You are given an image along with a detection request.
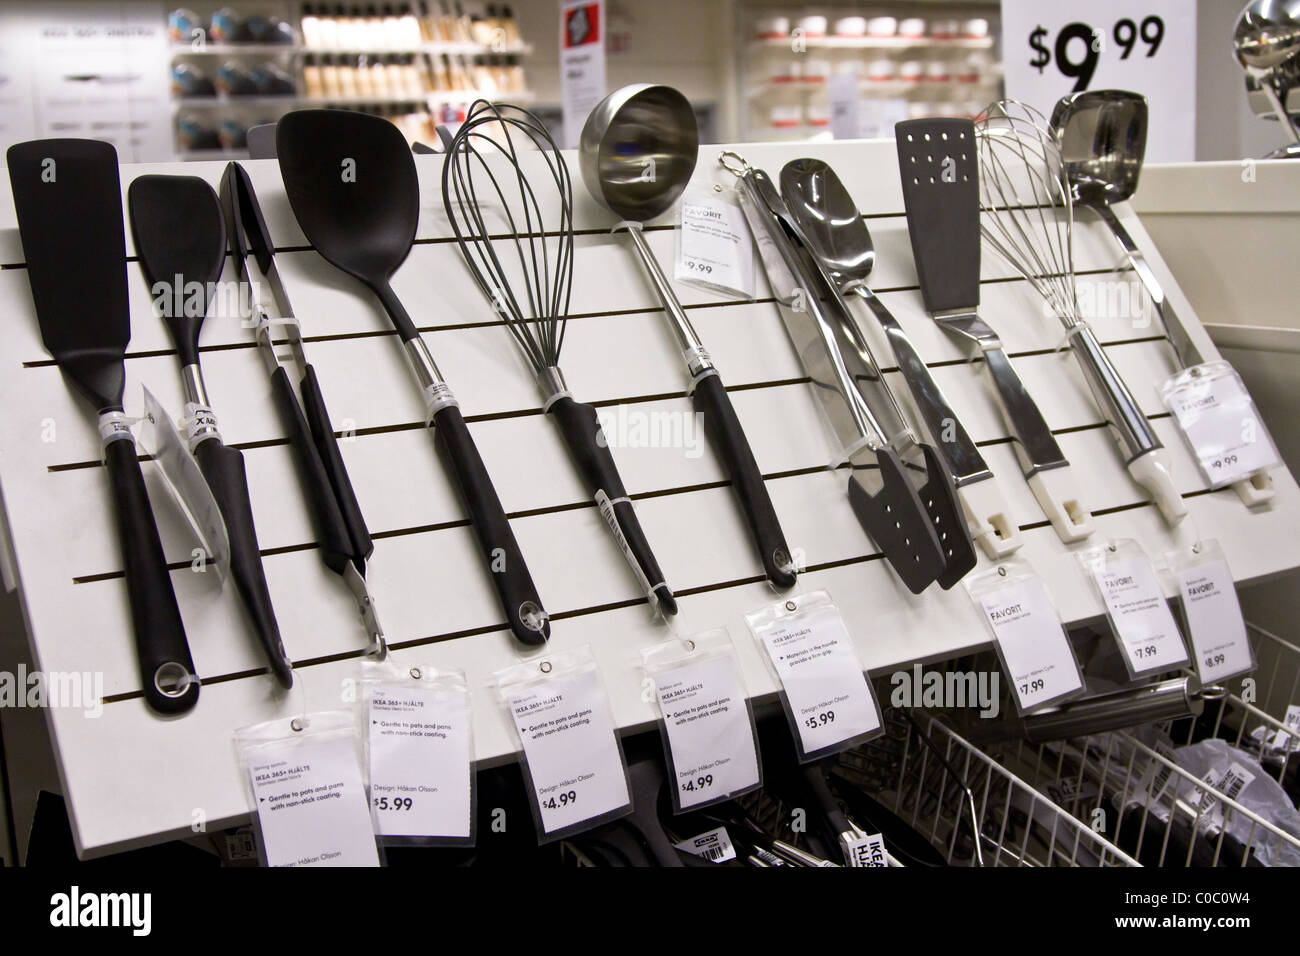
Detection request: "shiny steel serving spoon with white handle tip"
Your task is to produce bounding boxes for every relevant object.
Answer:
[781,159,1023,561]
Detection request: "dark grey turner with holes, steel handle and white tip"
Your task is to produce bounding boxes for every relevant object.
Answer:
[894,118,1093,542]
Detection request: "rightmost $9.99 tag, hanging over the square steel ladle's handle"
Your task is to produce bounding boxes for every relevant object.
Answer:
[1164,362,1278,488]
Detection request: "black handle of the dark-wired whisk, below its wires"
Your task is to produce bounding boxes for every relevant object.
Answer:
[549,398,677,614]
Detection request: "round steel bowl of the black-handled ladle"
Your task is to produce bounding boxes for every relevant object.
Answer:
[579,83,699,222]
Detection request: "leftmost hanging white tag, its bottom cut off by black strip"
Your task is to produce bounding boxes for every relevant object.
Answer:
[248,736,380,866]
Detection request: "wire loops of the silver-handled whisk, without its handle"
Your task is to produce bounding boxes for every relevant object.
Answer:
[975,100,1083,329]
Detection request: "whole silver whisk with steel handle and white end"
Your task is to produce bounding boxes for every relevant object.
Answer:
[975,100,1187,523]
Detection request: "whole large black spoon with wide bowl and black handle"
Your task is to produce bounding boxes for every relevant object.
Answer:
[276,109,550,645]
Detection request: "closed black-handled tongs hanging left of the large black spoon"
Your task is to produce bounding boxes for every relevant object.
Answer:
[221,163,387,658]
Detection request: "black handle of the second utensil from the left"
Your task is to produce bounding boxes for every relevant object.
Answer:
[194,438,294,687]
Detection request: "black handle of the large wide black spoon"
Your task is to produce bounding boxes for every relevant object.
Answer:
[433,405,551,645]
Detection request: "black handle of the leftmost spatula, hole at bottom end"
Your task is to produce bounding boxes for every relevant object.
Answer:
[104,438,199,714]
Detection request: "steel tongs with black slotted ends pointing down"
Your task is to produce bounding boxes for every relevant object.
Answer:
[719,152,975,594]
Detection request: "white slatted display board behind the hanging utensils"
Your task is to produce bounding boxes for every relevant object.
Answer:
[0,142,1300,855]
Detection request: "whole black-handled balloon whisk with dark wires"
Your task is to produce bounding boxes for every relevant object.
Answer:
[442,100,677,614]
